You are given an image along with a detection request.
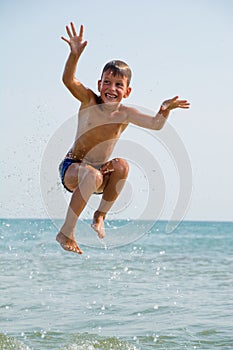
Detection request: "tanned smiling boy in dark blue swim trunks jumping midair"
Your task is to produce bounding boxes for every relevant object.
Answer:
[56,23,189,254]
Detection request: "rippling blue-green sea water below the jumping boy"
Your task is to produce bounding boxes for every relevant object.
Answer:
[0,219,233,350]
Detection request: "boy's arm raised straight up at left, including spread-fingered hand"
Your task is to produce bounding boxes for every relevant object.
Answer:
[62,23,93,104]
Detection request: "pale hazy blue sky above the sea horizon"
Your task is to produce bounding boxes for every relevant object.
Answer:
[0,0,233,221]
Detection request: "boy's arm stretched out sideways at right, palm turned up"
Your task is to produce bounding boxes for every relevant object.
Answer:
[126,96,190,130]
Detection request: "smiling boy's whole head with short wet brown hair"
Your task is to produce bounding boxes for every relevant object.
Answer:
[98,60,132,103]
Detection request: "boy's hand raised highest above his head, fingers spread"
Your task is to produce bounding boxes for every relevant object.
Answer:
[61,22,87,55]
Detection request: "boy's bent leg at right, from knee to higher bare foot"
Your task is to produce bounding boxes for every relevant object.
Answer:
[92,158,129,238]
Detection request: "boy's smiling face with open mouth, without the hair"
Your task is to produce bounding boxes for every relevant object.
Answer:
[98,71,131,103]
